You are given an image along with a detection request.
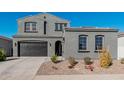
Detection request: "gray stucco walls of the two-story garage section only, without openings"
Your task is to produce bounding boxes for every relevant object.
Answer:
[13,13,70,56]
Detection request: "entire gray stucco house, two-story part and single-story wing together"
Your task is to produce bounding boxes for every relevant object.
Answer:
[13,13,118,59]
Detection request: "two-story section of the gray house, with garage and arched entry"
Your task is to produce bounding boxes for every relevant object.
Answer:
[13,13,69,56]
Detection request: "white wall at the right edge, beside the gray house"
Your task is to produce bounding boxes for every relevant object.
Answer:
[118,37,124,59]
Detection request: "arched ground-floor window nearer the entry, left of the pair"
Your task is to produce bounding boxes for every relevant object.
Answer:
[79,35,87,50]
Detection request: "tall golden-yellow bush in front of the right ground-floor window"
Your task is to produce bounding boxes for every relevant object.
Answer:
[100,48,112,68]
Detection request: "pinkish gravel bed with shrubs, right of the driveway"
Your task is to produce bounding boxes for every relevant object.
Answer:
[37,49,124,75]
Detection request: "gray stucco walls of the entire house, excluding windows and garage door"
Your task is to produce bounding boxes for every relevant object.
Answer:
[13,13,118,59]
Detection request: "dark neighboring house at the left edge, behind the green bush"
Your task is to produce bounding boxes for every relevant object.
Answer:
[0,36,12,56]
